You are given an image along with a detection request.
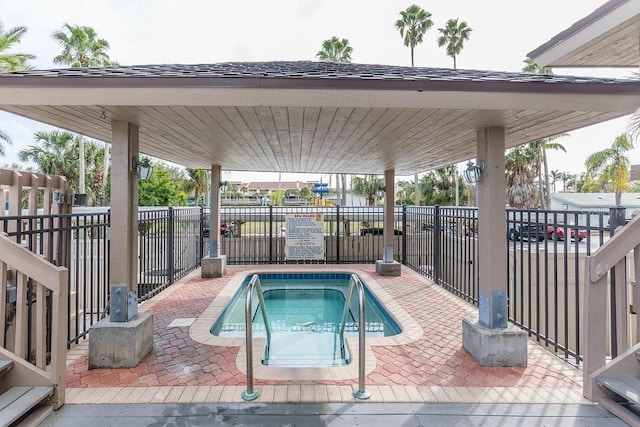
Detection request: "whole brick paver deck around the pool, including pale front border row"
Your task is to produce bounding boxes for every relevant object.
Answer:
[67,265,588,403]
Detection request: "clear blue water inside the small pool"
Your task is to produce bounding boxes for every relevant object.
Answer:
[211,273,400,366]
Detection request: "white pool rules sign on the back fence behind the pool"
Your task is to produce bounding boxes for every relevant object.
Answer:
[284,213,324,260]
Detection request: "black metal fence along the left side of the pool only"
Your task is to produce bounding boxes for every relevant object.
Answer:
[0,208,202,354]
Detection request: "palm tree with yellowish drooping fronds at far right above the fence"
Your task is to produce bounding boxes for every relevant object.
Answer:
[584,133,633,206]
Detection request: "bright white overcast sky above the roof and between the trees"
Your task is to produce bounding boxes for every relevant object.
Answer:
[0,0,640,182]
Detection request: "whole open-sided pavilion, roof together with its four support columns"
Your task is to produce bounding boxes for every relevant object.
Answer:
[0,62,640,367]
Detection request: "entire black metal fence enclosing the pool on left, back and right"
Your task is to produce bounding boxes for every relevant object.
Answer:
[0,202,616,363]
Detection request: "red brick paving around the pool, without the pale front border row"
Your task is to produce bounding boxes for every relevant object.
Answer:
[67,265,578,388]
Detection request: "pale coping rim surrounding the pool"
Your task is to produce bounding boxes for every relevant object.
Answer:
[189,265,424,381]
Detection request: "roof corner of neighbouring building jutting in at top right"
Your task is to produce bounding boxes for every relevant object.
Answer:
[527,0,640,68]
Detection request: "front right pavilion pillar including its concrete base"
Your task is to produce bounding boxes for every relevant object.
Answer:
[462,127,527,366]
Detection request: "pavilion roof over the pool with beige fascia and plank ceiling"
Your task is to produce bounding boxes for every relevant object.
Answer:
[0,62,640,175]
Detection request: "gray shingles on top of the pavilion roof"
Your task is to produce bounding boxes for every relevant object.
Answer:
[0,61,637,86]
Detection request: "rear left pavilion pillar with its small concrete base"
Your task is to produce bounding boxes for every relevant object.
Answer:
[200,165,227,278]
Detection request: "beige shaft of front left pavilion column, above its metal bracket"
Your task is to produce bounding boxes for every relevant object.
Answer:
[109,121,138,290]
